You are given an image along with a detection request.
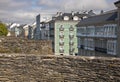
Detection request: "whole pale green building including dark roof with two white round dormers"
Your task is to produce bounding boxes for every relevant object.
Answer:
[49,12,86,55]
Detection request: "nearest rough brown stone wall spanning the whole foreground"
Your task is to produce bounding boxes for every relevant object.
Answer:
[0,54,120,82]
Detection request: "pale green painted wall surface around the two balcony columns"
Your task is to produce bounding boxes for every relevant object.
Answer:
[54,21,78,55]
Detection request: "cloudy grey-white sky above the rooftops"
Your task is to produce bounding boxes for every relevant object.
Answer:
[0,0,117,24]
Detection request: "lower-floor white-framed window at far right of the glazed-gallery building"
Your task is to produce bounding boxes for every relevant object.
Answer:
[107,40,117,55]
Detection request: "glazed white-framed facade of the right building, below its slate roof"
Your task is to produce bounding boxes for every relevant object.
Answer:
[77,23,117,56]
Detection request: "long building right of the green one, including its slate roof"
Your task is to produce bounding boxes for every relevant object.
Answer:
[77,10,119,56]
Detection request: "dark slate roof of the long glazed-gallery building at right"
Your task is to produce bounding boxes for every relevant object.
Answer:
[76,11,117,26]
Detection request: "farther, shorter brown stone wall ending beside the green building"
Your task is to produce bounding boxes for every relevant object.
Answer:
[0,37,53,55]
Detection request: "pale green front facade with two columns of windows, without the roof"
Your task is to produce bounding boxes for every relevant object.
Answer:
[54,21,78,55]
